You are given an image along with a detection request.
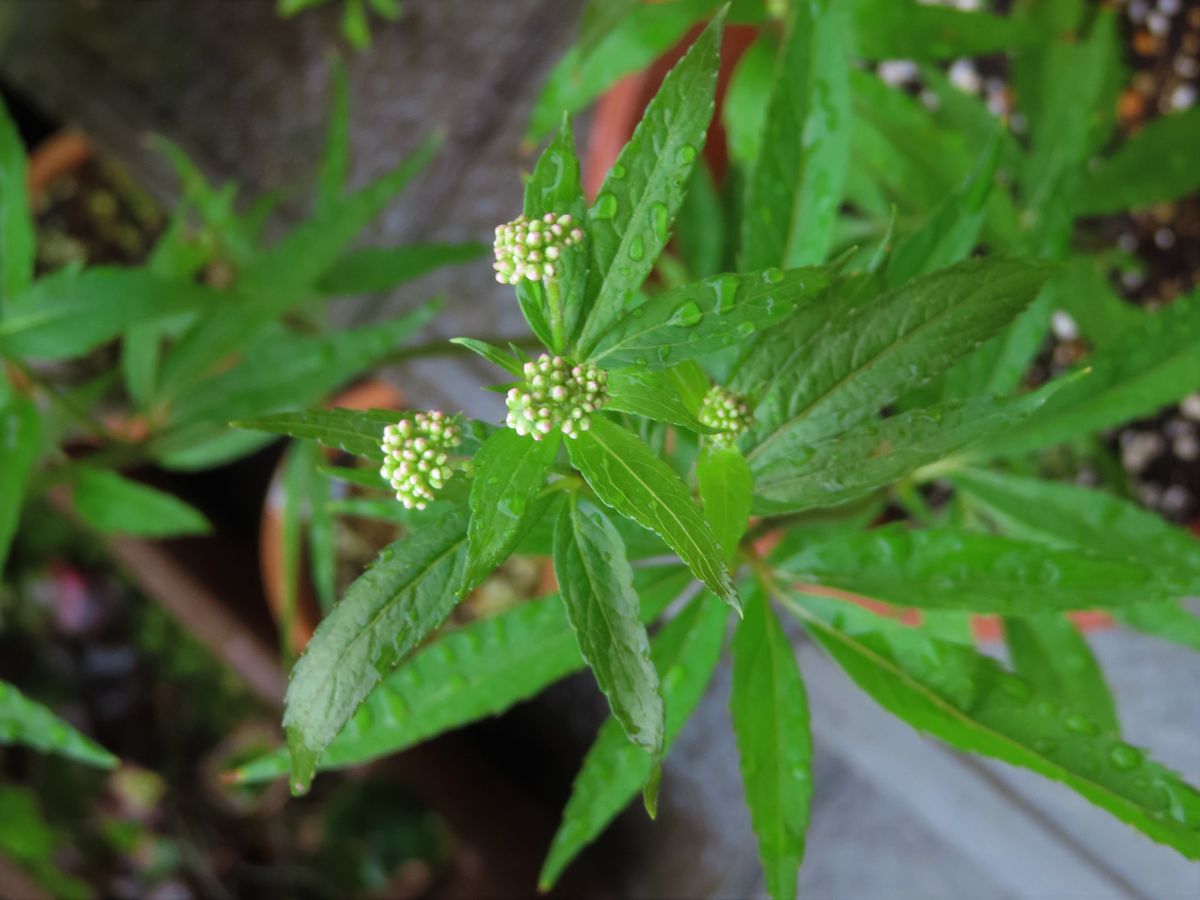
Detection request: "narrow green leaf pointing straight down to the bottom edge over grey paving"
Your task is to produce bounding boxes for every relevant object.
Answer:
[730,592,812,900]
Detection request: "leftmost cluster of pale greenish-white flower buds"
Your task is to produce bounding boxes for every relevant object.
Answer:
[379,412,462,509]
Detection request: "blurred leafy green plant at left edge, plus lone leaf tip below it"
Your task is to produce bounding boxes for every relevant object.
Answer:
[0,67,485,766]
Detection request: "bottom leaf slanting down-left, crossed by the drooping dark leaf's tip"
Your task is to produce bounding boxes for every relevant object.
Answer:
[538,594,727,890]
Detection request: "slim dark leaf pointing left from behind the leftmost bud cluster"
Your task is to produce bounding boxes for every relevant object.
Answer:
[232,408,487,464]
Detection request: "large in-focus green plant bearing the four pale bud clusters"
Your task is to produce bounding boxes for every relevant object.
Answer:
[231,1,1200,896]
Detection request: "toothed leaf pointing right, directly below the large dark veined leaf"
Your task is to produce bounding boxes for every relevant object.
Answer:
[751,376,1065,514]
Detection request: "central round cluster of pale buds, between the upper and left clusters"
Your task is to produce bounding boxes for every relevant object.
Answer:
[505,354,608,440]
